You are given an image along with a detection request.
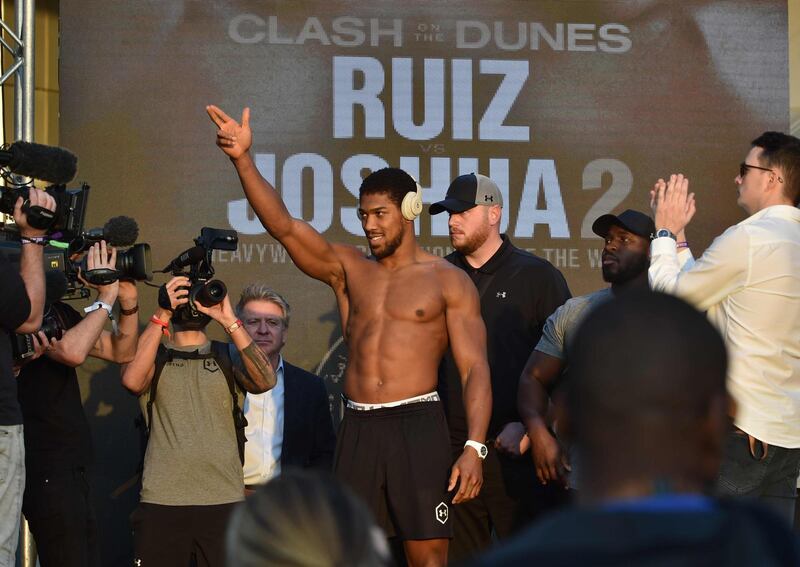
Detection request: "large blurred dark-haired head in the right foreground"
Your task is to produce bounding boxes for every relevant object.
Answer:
[567,293,729,503]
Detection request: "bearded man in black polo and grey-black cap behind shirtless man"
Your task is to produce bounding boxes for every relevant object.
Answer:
[430,173,570,562]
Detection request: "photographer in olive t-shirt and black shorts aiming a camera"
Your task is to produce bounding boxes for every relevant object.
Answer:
[122,229,276,567]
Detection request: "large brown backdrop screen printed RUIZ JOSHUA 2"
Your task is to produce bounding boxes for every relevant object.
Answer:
[60,0,789,560]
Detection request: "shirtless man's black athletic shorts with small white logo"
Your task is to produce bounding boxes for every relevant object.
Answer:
[334,401,453,540]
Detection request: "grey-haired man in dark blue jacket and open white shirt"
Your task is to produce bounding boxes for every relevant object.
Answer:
[236,284,336,490]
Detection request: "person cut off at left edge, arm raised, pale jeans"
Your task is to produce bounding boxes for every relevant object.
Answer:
[0,188,55,565]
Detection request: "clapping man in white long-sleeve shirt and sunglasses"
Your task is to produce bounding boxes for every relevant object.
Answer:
[649,132,800,521]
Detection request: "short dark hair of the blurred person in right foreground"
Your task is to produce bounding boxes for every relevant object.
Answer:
[565,291,727,475]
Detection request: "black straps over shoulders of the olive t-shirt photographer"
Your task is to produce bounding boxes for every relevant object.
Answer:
[144,341,247,465]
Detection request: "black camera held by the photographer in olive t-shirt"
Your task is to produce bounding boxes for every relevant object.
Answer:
[158,227,239,322]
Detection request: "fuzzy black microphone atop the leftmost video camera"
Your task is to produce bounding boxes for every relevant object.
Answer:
[0,142,78,185]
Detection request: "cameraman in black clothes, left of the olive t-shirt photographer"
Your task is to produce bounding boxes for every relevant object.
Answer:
[18,240,139,567]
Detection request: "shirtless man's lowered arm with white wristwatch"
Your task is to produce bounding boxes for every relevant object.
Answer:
[442,267,492,504]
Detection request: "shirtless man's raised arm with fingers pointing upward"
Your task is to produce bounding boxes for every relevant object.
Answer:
[206,105,344,287]
